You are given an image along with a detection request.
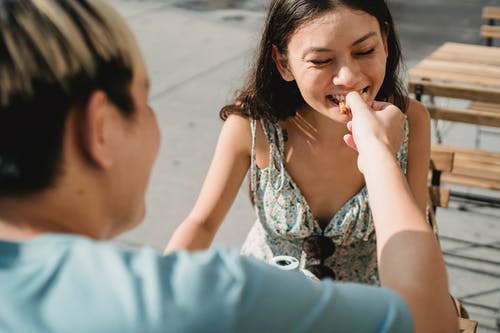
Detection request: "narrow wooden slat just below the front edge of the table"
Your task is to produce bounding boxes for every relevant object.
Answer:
[427,106,500,127]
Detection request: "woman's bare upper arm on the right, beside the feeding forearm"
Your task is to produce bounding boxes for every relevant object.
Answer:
[406,99,430,212]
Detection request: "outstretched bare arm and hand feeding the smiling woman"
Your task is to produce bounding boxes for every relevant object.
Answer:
[344,92,457,332]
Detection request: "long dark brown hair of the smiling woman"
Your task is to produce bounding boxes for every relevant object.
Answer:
[220,0,407,122]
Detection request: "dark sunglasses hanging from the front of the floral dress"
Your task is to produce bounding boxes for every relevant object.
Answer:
[302,235,335,280]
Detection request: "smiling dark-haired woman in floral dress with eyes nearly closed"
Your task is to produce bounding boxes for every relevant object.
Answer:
[167,0,429,284]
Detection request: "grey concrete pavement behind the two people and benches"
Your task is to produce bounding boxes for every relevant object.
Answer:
[110,0,500,332]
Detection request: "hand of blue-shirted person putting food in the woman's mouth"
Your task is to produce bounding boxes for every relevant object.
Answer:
[344,92,406,172]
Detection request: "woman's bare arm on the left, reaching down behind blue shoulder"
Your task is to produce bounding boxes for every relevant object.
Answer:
[165,115,251,252]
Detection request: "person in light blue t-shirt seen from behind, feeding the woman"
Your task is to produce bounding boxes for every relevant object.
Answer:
[0,0,457,333]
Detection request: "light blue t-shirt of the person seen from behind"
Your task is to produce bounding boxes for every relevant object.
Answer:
[0,234,413,333]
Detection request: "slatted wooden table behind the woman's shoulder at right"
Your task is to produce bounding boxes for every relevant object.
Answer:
[408,43,500,127]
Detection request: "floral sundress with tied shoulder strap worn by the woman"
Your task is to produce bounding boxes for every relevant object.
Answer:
[241,119,409,285]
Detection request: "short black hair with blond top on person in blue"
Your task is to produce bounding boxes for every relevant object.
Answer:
[0,0,134,197]
